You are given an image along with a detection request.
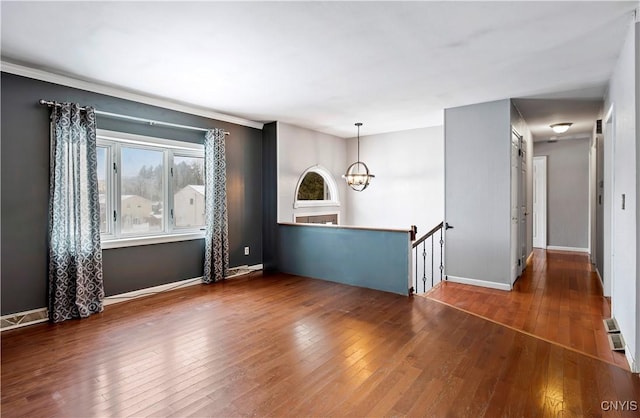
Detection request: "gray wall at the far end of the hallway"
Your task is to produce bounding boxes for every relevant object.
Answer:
[533,139,589,249]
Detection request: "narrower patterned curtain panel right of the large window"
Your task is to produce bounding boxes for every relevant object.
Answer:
[202,129,229,283]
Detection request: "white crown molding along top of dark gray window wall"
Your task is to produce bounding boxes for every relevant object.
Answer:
[0,61,264,129]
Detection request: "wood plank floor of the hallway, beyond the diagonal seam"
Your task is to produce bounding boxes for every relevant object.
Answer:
[426,249,629,370]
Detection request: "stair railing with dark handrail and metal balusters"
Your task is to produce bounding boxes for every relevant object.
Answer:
[409,222,446,294]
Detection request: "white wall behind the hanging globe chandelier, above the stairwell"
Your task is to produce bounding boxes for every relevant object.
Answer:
[343,126,444,236]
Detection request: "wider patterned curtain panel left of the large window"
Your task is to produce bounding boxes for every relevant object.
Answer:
[49,103,104,322]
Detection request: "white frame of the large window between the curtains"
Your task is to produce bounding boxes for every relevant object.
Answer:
[96,129,204,249]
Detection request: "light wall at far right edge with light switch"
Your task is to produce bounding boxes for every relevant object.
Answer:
[604,18,640,372]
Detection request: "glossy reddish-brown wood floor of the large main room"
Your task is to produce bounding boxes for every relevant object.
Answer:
[0,266,640,417]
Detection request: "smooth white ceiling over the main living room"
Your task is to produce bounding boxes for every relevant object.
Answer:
[1,1,639,137]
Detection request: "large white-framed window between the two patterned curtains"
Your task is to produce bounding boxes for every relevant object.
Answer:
[97,130,205,248]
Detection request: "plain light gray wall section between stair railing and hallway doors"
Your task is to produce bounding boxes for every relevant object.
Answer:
[444,99,511,289]
